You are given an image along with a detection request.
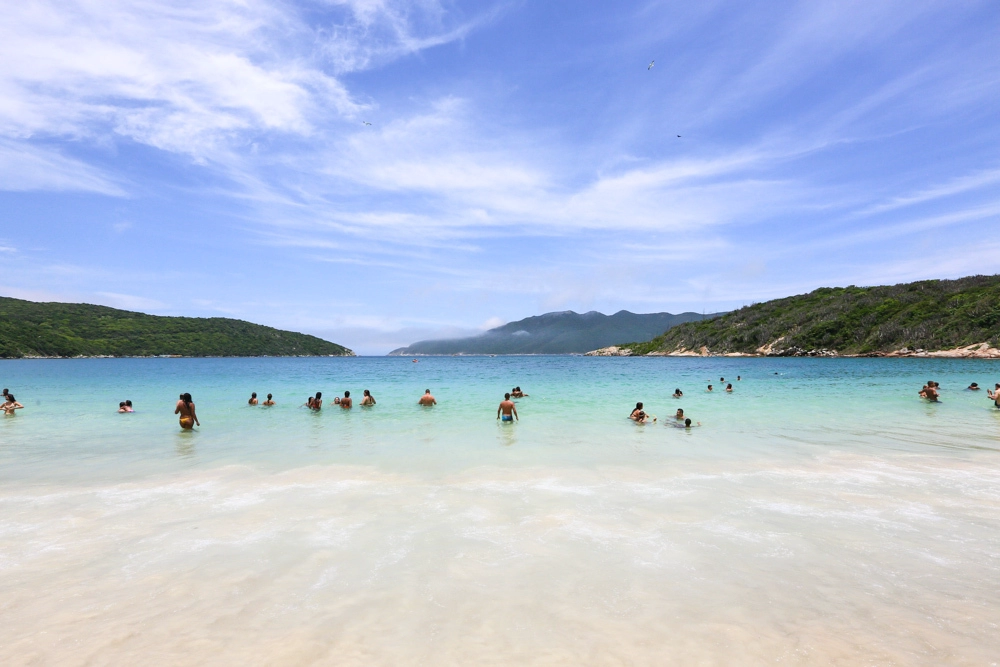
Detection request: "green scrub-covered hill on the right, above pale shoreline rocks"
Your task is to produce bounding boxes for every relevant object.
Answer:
[623,276,1000,356]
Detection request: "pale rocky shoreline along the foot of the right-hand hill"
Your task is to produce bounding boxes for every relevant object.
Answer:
[584,339,1000,359]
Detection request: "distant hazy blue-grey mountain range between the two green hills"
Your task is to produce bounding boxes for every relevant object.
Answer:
[389,310,718,356]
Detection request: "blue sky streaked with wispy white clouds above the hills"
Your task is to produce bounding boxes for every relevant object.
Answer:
[0,0,1000,354]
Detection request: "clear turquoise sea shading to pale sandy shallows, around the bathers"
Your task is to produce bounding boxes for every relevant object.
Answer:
[0,357,1000,665]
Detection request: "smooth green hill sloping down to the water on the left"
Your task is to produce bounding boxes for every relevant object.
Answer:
[0,297,354,358]
